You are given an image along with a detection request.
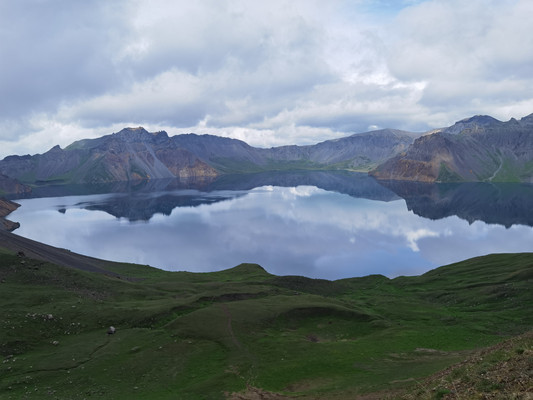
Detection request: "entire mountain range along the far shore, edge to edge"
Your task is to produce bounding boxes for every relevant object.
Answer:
[0,114,533,193]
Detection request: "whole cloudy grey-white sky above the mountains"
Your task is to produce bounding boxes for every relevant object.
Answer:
[0,0,533,157]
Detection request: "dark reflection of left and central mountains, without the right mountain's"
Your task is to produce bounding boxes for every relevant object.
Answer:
[21,171,399,222]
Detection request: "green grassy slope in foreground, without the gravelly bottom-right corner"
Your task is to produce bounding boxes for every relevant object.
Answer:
[0,250,533,399]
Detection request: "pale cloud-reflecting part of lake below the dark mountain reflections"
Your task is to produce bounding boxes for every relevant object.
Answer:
[12,186,533,279]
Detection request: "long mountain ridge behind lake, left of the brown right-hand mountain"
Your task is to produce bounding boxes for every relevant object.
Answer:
[0,128,417,185]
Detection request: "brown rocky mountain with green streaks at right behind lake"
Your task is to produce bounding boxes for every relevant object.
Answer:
[370,114,533,182]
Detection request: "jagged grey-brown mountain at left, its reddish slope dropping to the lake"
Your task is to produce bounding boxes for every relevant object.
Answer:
[0,128,217,184]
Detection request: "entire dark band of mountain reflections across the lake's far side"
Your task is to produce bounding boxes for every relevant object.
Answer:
[35,171,533,228]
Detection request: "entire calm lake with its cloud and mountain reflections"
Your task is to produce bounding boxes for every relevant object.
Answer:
[9,172,533,279]
